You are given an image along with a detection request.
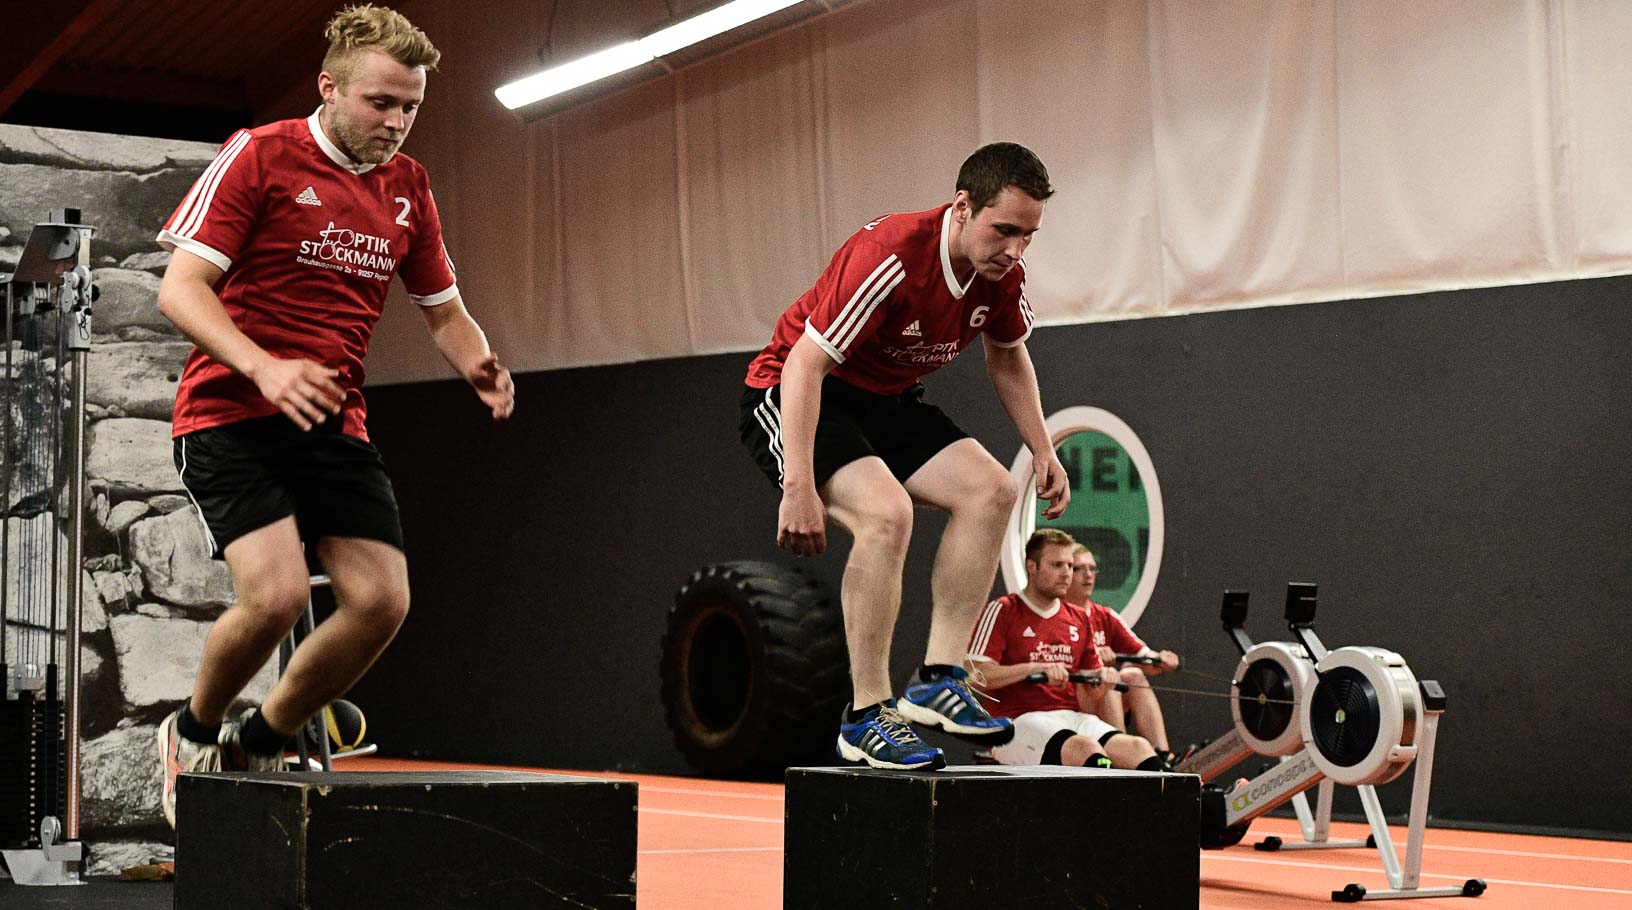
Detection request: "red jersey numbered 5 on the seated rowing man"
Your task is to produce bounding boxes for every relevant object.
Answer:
[969,594,1100,718]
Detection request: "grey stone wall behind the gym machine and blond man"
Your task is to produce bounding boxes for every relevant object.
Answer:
[0,124,273,874]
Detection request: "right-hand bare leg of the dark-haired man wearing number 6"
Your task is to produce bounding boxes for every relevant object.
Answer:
[906,439,1017,667]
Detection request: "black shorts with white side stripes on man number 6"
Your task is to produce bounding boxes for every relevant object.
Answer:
[738,377,969,488]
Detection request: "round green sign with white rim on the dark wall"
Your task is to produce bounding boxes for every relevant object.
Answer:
[1002,408,1162,625]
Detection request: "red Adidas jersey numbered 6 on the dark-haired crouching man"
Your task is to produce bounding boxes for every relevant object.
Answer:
[747,204,1031,395]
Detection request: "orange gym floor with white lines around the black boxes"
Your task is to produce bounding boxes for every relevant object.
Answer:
[347,757,1632,910]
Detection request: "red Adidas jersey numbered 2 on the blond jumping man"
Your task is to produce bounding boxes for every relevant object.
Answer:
[158,114,459,439]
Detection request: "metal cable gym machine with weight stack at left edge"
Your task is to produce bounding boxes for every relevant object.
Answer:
[0,209,96,886]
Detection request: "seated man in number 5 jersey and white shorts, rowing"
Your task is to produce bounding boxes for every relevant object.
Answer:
[968,528,1169,771]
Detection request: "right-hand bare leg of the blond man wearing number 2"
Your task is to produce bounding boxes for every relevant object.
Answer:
[261,537,408,736]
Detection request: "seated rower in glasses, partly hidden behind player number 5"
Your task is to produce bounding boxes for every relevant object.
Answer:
[1066,543,1178,765]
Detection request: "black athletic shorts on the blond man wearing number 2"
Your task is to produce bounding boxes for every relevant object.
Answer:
[173,414,403,559]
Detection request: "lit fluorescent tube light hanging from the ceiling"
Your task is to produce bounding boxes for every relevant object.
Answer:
[493,0,801,111]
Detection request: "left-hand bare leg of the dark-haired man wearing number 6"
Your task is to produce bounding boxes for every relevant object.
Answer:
[821,457,912,708]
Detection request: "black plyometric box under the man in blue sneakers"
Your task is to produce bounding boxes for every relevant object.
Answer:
[782,766,1201,910]
